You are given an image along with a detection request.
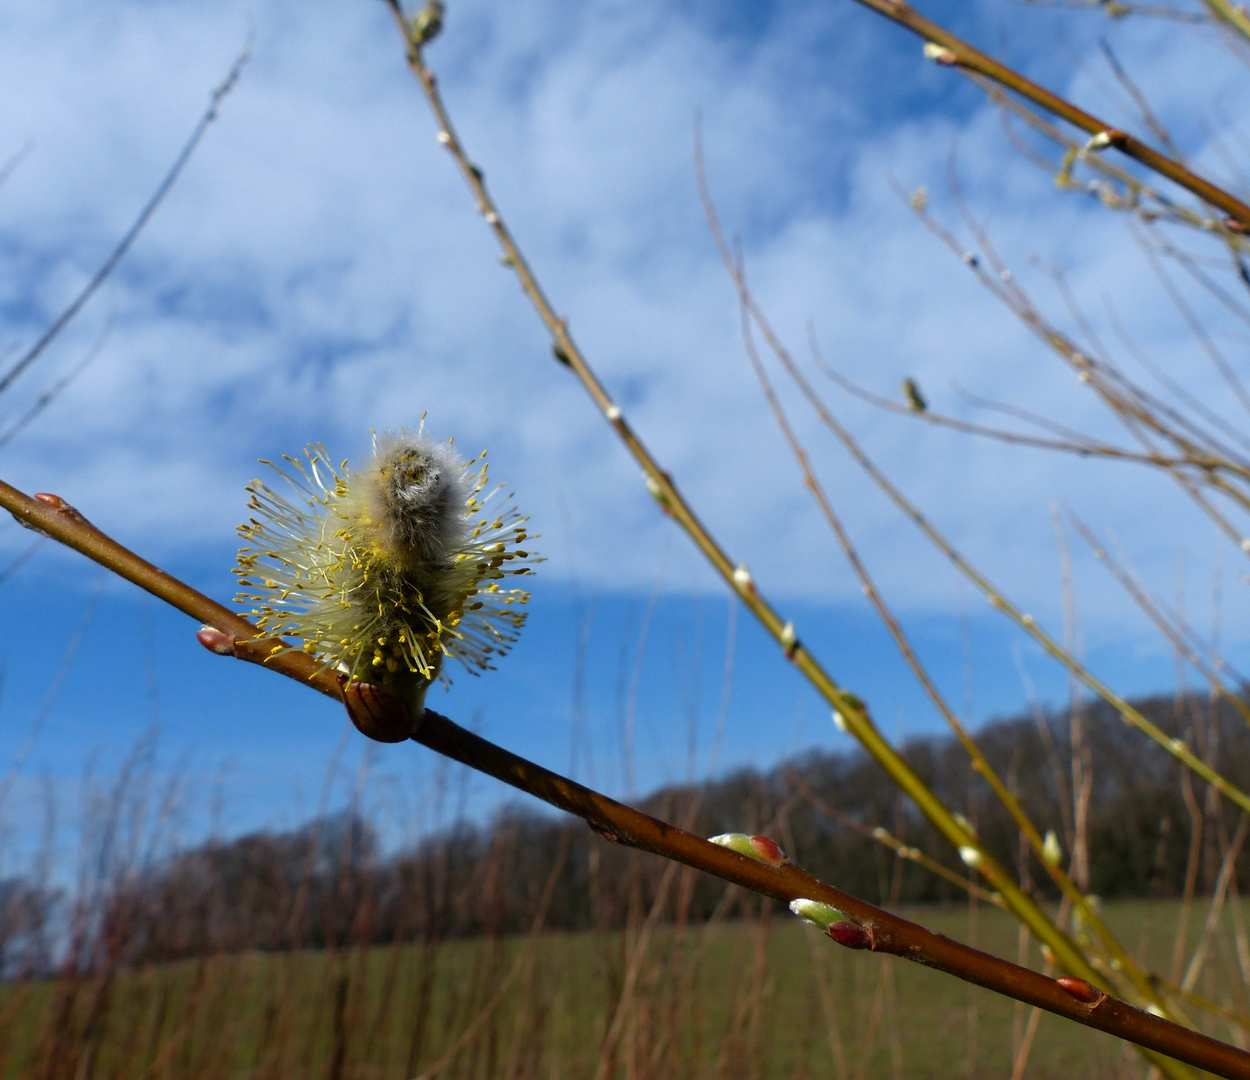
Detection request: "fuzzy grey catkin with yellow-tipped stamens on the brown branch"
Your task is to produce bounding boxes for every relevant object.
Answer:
[235,433,535,711]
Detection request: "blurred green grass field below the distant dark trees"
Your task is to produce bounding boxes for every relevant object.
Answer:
[0,901,1246,1080]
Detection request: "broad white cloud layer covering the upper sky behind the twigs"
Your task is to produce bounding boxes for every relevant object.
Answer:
[0,0,1245,660]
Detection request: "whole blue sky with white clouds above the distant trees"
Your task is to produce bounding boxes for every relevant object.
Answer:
[0,0,1250,875]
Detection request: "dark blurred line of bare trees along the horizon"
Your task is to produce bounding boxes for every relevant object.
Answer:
[0,698,1250,974]
